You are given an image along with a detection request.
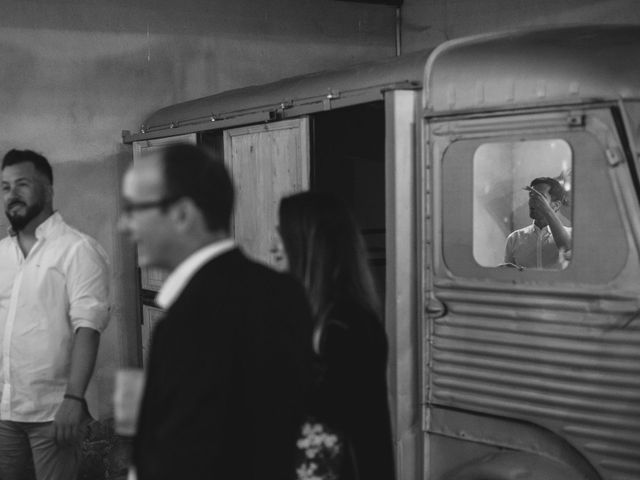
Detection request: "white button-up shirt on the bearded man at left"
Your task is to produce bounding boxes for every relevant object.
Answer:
[0,213,109,422]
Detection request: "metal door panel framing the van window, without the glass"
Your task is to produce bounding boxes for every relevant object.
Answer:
[432,109,630,284]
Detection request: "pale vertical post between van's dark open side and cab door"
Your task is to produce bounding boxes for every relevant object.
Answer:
[385,90,422,480]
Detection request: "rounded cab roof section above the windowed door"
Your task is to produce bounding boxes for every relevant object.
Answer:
[423,25,640,114]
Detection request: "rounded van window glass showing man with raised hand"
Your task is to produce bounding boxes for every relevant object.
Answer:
[473,139,573,270]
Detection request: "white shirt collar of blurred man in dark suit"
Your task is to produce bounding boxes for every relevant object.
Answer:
[156,238,235,310]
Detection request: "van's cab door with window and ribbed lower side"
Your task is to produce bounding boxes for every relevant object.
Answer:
[420,106,640,480]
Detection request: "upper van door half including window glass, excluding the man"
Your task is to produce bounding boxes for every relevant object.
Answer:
[440,114,633,285]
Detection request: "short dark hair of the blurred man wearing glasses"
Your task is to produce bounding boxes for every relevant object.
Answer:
[161,143,234,231]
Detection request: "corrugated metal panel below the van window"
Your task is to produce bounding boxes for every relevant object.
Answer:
[429,289,640,480]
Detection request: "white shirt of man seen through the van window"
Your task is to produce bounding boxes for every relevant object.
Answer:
[504,222,571,270]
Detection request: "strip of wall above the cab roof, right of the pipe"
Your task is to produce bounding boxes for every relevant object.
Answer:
[402,0,640,53]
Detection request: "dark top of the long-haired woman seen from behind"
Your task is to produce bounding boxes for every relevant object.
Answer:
[311,302,395,480]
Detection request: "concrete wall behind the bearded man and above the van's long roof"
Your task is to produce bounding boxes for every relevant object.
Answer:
[0,0,394,418]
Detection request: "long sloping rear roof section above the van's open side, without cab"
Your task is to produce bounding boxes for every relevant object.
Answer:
[123,52,429,143]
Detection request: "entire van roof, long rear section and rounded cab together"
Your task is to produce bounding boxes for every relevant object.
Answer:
[123,25,640,143]
